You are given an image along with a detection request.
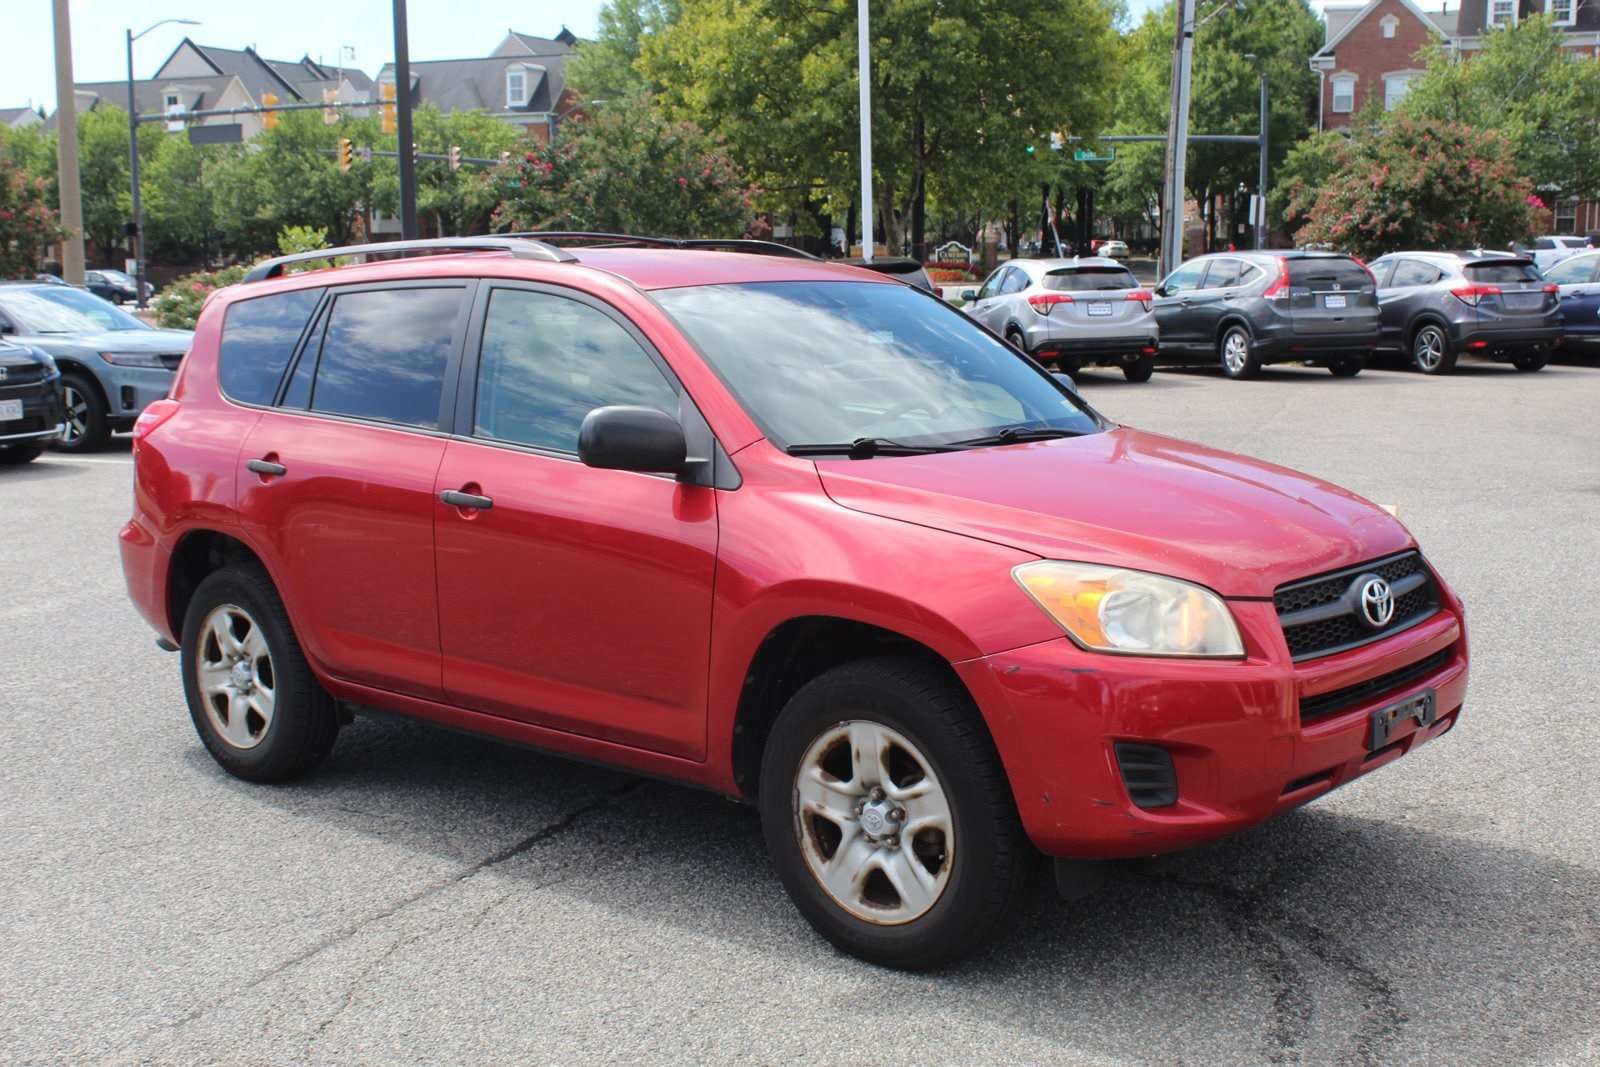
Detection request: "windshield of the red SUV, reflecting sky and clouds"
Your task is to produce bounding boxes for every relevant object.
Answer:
[654,282,1101,454]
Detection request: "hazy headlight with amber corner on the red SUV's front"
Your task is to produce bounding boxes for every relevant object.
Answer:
[1011,560,1245,657]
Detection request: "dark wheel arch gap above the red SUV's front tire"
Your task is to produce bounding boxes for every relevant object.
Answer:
[731,616,966,800]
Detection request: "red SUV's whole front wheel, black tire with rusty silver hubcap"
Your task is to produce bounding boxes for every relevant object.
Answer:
[760,659,1037,969]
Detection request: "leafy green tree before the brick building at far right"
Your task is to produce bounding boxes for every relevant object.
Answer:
[1398,14,1600,198]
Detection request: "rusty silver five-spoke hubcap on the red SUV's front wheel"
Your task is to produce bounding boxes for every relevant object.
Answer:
[794,720,955,925]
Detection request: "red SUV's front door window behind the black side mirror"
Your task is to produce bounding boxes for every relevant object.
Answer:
[472,290,678,453]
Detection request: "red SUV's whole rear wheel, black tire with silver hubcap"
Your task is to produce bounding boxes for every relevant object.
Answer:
[182,563,339,782]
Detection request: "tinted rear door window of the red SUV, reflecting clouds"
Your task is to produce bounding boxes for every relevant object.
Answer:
[302,288,466,429]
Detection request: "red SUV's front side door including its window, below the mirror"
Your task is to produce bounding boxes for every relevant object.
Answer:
[434,283,717,760]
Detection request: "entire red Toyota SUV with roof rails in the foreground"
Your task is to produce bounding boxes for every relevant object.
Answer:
[122,235,1467,968]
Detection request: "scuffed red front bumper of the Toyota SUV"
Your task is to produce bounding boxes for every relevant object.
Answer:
[960,595,1467,859]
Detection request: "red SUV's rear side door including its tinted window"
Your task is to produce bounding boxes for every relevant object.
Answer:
[235,282,474,701]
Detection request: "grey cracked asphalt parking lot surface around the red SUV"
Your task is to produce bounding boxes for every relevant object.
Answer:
[0,356,1600,1065]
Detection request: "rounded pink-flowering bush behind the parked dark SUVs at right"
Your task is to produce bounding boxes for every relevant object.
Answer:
[1290,120,1544,259]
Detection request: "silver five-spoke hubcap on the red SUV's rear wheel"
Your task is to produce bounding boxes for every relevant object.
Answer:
[195,605,275,749]
